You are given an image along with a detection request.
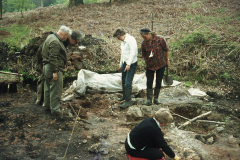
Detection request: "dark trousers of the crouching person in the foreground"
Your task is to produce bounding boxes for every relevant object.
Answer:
[125,140,163,160]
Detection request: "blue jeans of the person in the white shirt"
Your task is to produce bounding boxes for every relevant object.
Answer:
[122,62,137,89]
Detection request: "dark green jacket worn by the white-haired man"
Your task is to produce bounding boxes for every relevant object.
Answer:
[42,34,67,73]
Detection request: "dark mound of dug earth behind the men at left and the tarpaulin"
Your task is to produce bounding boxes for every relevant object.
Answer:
[0,31,120,80]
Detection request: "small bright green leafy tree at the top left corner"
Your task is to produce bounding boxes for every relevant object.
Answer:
[9,0,33,17]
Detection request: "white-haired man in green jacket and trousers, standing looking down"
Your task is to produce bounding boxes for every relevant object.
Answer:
[42,26,72,117]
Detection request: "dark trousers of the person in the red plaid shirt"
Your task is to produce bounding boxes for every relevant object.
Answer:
[146,66,165,89]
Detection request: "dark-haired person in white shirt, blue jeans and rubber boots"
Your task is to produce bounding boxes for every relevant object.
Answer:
[113,28,138,108]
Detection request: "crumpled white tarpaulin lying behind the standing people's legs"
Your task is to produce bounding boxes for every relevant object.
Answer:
[62,69,181,101]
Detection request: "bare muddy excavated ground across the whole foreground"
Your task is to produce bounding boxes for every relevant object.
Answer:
[0,81,240,160]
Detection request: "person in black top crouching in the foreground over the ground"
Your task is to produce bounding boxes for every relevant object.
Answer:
[125,108,180,160]
